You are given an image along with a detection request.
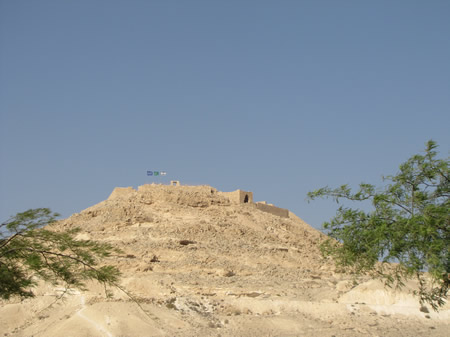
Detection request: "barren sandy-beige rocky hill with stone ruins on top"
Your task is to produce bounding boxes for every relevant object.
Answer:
[0,185,450,337]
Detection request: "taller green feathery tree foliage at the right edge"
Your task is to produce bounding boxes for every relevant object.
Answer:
[308,140,450,310]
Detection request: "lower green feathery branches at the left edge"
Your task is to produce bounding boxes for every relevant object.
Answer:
[0,208,120,299]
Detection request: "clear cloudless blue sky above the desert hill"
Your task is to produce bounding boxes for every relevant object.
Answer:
[0,0,450,227]
